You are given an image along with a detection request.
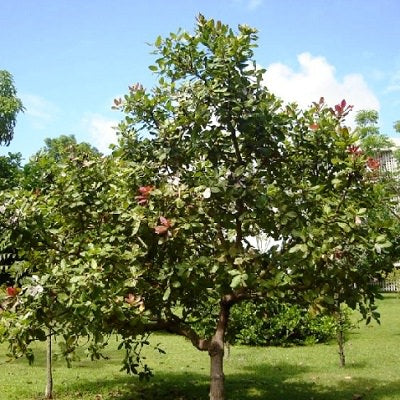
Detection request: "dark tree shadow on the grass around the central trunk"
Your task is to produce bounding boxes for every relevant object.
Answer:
[51,363,400,400]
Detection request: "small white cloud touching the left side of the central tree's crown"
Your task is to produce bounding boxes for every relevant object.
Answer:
[83,114,118,153]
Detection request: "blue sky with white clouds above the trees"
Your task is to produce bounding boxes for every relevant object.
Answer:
[0,0,400,159]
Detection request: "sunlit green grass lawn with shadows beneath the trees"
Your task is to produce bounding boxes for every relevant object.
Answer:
[0,295,400,400]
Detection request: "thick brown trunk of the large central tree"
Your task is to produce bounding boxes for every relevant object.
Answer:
[208,300,231,400]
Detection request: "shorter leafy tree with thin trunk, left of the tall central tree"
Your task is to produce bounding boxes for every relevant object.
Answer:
[0,145,138,398]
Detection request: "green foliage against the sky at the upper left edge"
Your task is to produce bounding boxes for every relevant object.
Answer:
[0,70,24,146]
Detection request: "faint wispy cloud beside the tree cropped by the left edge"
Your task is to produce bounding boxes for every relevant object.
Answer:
[21,93,60,130]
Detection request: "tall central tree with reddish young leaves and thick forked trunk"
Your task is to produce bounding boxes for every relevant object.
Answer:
[110,16,398,400]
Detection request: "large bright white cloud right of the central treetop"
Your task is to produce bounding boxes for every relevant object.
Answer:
[264,53,379,125]
